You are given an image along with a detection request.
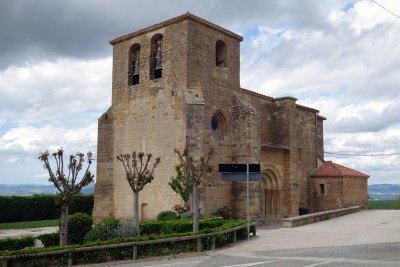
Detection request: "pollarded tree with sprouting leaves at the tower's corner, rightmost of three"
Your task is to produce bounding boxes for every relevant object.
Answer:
[175,148,214,231]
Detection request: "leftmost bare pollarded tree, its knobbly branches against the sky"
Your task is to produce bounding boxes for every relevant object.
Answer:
[39,148,94,246]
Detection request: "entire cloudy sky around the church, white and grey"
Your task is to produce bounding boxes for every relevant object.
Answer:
[0,0,400,184]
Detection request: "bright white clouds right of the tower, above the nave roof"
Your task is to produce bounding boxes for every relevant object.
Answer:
[241,0,400,183]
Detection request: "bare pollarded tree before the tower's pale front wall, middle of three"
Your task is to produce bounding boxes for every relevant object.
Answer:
[117,151,161,226]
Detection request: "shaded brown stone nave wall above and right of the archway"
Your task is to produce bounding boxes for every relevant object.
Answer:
[244,90,323,219]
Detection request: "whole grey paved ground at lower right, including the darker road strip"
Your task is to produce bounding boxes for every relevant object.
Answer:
[86,210,400,267]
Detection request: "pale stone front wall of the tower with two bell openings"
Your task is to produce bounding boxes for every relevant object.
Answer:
[95,21,194,223]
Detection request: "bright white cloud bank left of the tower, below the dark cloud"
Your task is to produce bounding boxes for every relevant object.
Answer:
[0,58,111,126]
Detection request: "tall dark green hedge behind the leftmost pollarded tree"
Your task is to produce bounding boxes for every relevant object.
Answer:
[0,194,93,223]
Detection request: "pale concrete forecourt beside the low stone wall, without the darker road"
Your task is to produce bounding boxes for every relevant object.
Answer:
[218,210,400,255]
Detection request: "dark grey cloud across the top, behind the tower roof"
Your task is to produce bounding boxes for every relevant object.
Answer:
[0,0,344,69]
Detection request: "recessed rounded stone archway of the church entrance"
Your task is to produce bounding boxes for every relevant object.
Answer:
[261,164,282,219]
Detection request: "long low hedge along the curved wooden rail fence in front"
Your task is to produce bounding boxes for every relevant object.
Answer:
[0,220,255,266]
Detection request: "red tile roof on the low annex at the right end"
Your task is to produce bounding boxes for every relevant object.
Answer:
[310,161,369,178]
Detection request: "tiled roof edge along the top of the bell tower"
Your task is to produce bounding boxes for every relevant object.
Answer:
[110,12,243,45]
